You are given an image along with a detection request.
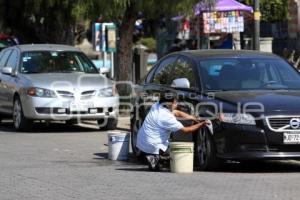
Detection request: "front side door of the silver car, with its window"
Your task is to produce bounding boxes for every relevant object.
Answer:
[2,50,20,114]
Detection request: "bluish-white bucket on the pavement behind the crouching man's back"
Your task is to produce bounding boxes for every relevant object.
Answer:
[108,132,129,160]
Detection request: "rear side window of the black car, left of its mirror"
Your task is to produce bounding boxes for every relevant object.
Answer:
[152,56,177,85]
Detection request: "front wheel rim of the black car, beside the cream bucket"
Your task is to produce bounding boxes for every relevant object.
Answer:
[197,130,208,166]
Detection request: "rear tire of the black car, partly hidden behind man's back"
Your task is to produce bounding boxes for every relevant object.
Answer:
[130,116,142,159]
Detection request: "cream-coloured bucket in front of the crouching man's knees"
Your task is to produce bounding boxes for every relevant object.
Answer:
[170,142,194,173]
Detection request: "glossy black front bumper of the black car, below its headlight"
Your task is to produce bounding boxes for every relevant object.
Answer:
[214,124,300,160]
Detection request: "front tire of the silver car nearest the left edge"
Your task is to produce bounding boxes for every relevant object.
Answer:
[13,97,33,131]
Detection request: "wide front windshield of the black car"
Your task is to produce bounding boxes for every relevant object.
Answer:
[199,58,300,91]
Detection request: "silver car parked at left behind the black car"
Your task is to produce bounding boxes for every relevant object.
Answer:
[0,44,119,131]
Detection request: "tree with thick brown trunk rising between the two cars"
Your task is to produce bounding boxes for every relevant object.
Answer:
[96,0,215,88]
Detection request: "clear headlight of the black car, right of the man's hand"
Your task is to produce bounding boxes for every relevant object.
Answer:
[220,113,256,125]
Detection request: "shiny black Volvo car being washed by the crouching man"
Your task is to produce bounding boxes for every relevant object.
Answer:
[131,50,300,170]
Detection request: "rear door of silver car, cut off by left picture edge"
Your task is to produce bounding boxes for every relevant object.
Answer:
[0,49,12,113]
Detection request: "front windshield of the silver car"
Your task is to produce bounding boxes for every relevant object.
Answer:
[21,51,98,74]
